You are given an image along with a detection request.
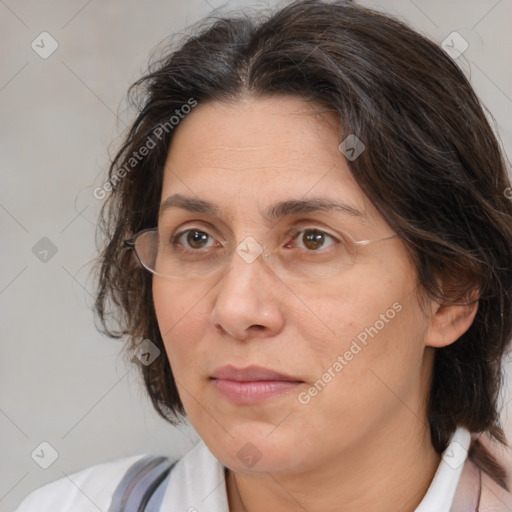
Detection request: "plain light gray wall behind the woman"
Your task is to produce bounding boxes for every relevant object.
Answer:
[0,0,512,511]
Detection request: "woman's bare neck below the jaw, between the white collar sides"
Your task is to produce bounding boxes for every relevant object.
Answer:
[226,418,441,512]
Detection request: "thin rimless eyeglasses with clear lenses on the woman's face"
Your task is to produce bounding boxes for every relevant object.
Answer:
[124,226,397,280]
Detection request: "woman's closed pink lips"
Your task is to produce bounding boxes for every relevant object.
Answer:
[210,365,304,405]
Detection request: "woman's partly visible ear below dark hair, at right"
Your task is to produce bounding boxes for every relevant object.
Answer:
[425,290,479,348]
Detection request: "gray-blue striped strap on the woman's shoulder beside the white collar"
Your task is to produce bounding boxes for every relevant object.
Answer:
[108,456,175,512]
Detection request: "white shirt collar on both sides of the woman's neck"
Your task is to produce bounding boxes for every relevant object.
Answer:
[161,427,471,512]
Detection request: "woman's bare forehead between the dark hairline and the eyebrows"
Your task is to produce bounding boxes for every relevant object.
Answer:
[162,96,384,230]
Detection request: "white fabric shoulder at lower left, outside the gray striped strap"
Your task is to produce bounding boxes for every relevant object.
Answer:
[12,455,148,512]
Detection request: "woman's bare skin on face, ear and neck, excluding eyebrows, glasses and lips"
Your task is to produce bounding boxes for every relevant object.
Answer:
[153,96,476,512]
